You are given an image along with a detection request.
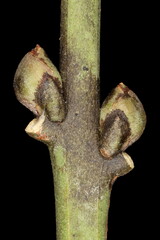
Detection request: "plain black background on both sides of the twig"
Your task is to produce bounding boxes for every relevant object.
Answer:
[0,0,160,240]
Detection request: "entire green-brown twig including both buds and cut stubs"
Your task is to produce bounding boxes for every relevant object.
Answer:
[14,0,146,240]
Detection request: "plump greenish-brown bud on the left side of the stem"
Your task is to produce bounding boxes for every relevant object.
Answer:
[14,45,65,121]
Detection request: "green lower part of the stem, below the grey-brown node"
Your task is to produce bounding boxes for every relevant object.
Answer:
[50,146,111,240]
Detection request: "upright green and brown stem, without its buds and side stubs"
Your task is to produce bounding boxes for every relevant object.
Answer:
[51,0,110,240]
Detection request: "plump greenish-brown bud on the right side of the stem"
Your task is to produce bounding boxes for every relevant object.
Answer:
[100,83,146,158]
